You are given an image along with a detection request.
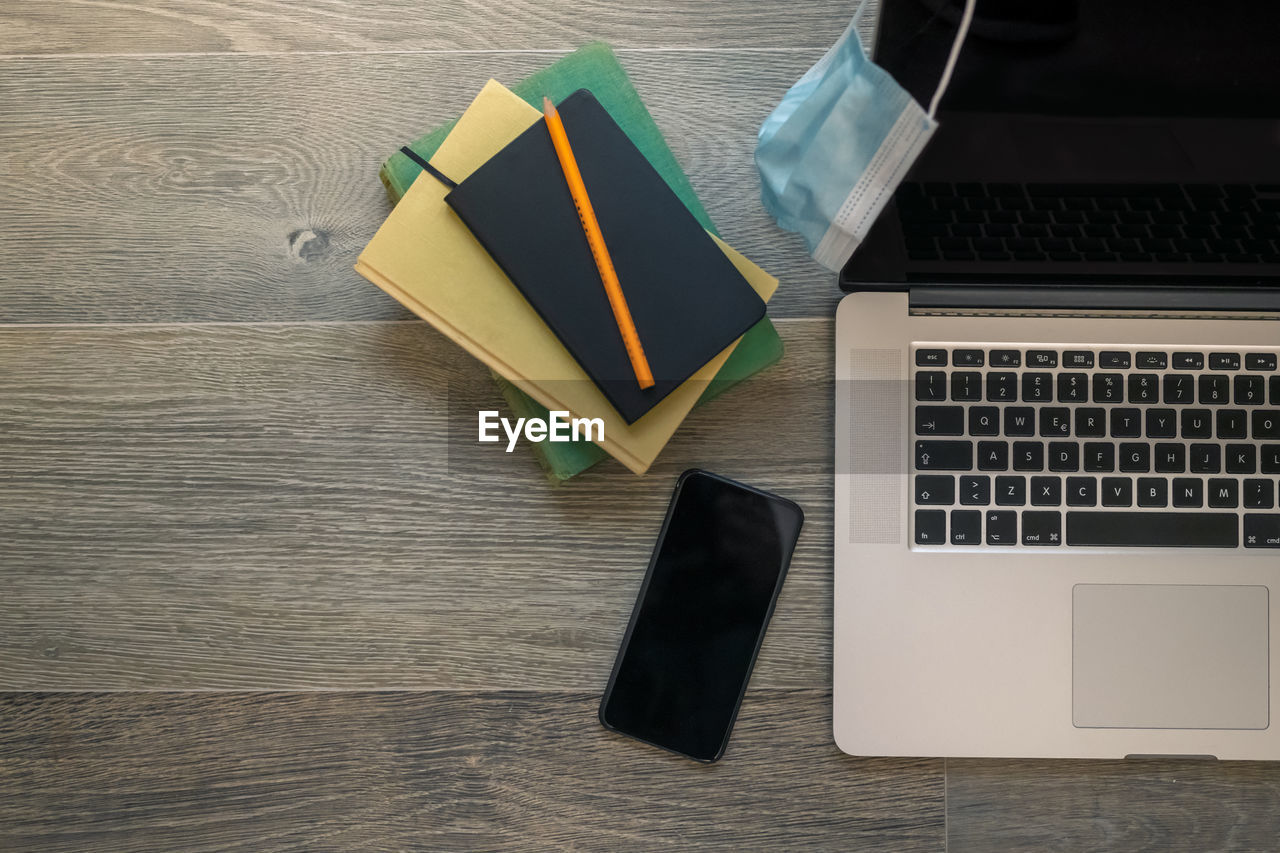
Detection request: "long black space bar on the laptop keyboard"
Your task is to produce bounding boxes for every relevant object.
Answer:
[1066,512,1240,548]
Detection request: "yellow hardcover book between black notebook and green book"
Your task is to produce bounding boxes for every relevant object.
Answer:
[356,81,777,474]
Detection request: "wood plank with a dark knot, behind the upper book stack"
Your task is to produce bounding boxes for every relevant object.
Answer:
[0,51,840,323]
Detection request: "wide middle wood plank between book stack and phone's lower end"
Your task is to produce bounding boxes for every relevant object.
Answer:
[0,320,832,690]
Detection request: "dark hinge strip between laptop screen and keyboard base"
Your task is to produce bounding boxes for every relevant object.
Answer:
[910,284,1280,315]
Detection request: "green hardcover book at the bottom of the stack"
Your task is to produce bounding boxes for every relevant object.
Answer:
[378,42,782,483]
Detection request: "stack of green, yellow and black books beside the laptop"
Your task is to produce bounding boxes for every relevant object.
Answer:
[356,45,782,482]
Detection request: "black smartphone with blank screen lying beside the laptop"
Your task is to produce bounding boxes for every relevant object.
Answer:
[600,469,804,762]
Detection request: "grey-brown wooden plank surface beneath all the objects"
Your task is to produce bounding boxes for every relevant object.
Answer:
[0,0,1280,852]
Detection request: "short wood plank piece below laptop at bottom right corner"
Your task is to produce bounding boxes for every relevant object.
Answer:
[946,760,1280,853]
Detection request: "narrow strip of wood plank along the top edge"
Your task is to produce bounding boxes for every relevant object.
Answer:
[0,0,852,55]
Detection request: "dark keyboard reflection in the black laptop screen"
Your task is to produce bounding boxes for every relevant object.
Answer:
[895,183,1280,258]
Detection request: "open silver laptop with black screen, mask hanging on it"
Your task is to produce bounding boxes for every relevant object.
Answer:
[833,0,1280,760]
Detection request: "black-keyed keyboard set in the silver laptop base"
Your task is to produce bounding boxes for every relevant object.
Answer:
[911,343,1280,549]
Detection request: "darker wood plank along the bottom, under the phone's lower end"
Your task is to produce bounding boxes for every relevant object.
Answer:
[0,690,943,853]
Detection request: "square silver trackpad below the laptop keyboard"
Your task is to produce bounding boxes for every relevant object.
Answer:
[1071,584,1270,729]
